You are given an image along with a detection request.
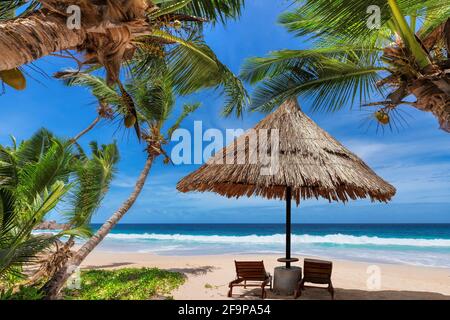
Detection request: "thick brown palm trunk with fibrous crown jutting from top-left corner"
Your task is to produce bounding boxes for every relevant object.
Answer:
[0,0,156,72]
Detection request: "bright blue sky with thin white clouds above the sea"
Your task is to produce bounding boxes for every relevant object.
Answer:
[0,0,450,223]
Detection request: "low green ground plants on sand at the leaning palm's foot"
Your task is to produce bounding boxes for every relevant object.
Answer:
[64,268,185,300]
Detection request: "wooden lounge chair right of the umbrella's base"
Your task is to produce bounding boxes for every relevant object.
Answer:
[295,259,334,299]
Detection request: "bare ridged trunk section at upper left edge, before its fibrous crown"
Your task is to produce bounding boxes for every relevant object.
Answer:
[0,11,87,71]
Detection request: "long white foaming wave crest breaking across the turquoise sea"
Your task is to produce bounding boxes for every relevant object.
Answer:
[107,233,450,248]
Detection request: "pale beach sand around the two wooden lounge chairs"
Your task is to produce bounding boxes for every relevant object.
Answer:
[82,251,450,300]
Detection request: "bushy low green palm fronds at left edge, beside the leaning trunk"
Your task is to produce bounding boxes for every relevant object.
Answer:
[0,129,118,284]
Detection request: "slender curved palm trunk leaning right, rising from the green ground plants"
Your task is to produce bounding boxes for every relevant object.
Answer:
[43,155,155,299]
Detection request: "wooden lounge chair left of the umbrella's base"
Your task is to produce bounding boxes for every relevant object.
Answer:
[228,261,272,299]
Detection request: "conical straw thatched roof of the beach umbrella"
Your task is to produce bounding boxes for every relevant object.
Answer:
[177,99,396,205]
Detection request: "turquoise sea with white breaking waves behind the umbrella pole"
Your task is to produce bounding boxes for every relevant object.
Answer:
[87,224,450,268]
